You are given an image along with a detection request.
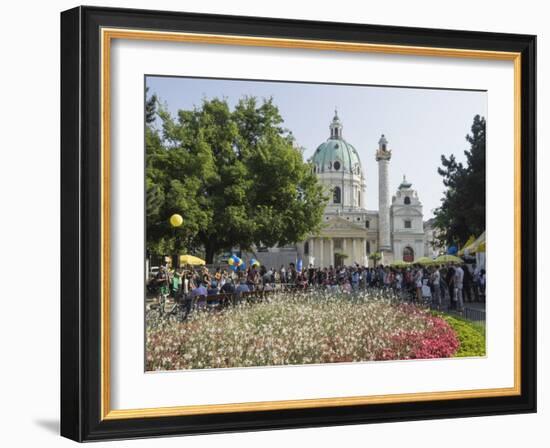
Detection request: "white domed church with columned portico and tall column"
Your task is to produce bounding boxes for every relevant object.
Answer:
[297,112,425,267]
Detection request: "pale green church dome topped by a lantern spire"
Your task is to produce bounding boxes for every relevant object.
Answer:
[311,111,361,174]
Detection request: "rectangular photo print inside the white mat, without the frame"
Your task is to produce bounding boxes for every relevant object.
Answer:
[143,74,492,372]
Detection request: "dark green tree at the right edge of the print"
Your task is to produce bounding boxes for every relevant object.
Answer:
[435,115,485,245]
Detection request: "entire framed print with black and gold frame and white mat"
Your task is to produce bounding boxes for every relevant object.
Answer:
[61,7,536,441]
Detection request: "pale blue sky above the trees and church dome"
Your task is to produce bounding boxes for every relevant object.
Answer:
[146,76,487,219]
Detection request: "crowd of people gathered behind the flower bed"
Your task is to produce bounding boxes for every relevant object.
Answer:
[148,263,486,311]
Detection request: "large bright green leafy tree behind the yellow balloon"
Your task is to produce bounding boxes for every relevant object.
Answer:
[146,93,326,262]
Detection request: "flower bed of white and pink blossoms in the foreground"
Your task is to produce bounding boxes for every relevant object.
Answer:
[146,293,459,370]
